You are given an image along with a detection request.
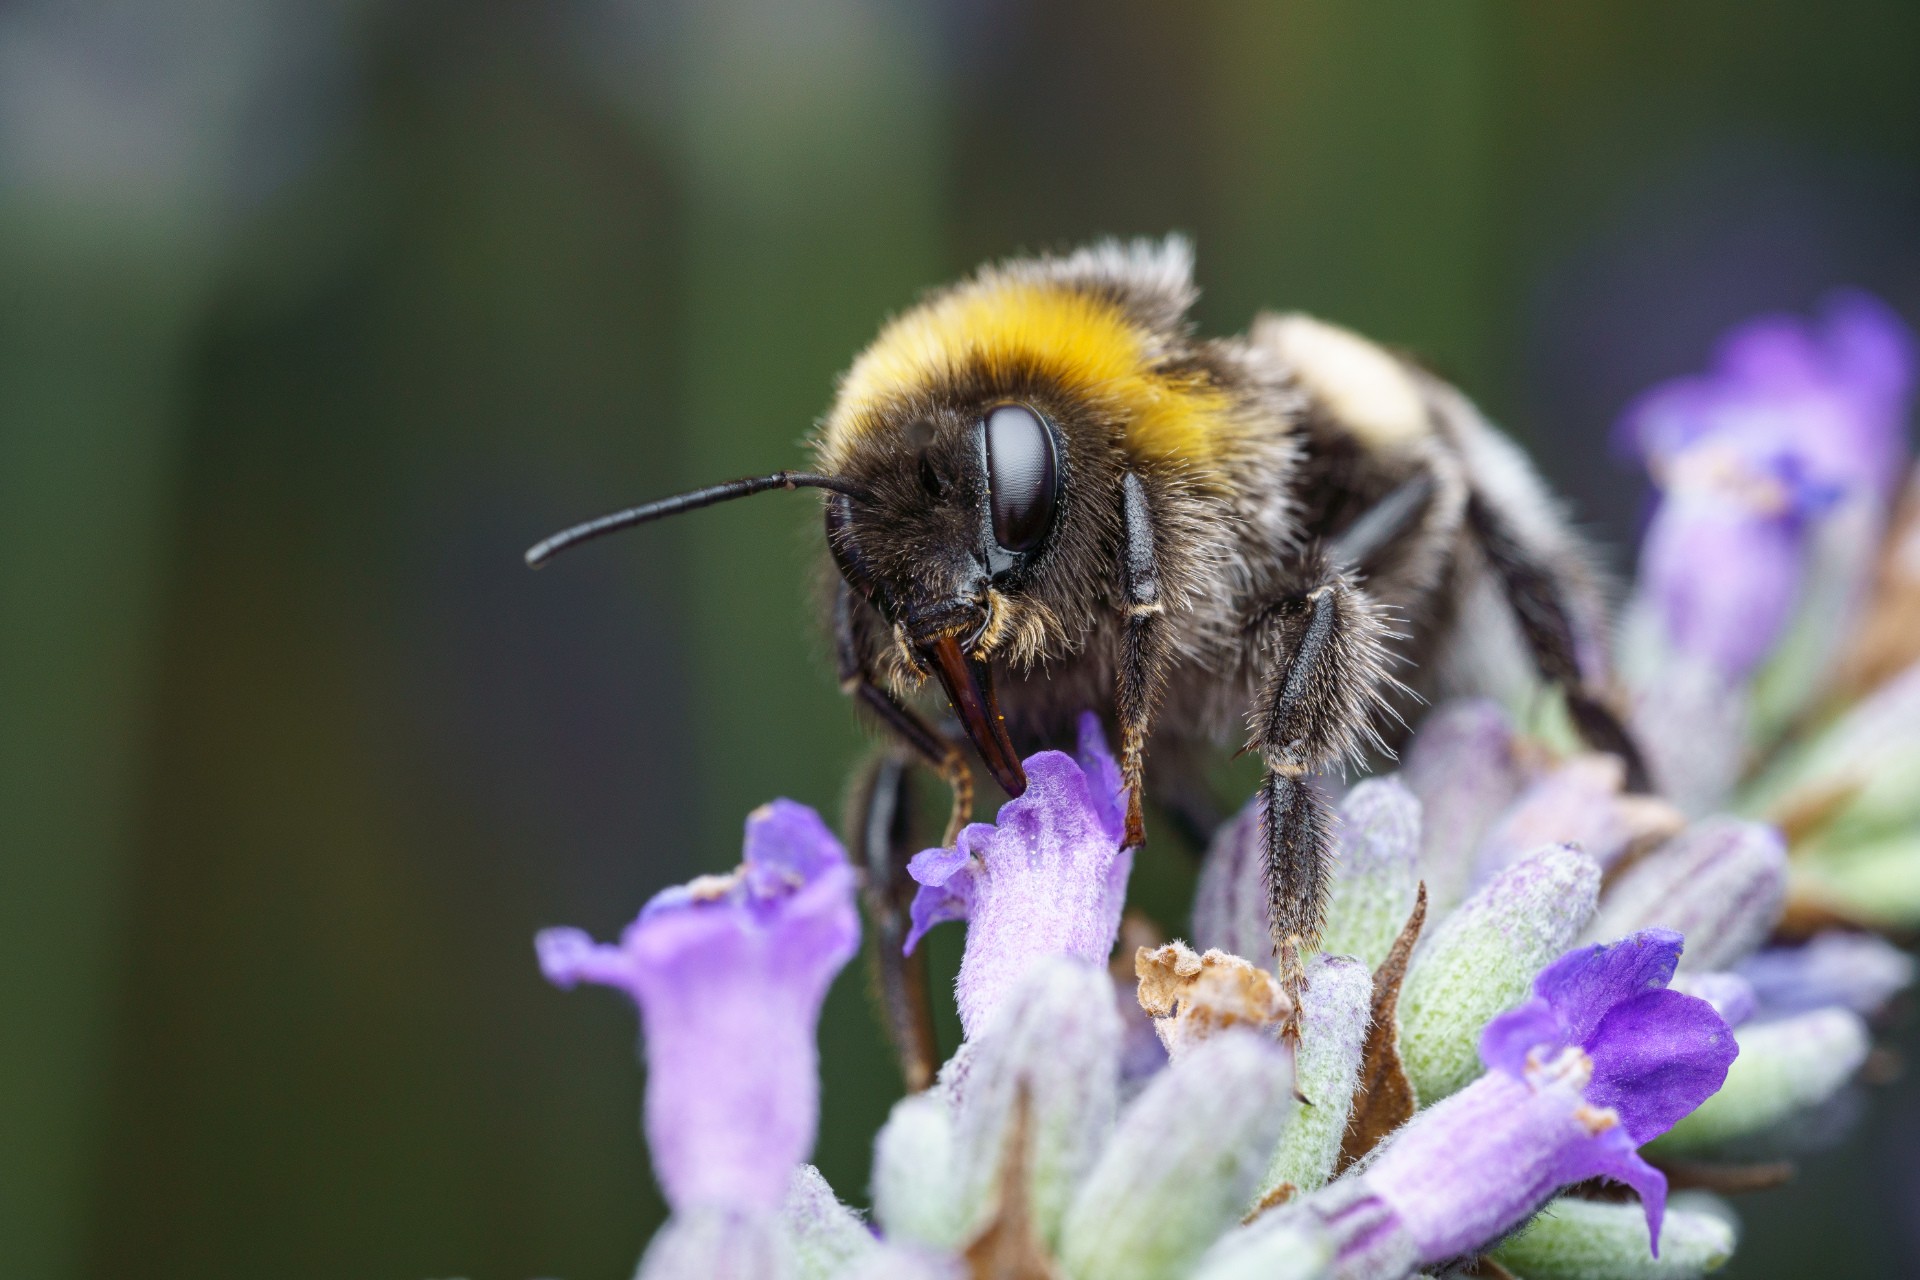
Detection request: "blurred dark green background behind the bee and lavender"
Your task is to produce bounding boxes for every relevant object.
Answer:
[11,0,1920,1280]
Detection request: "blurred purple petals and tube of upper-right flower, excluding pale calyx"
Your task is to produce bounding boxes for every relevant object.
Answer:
[1620,292,1914,679]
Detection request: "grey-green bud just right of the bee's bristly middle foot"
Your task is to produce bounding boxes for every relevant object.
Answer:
[1320,777,1421,971]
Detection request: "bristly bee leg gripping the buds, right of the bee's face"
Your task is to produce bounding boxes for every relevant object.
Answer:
[1248,555,1396,1036]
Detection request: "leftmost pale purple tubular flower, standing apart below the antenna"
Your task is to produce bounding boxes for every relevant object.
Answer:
[534,800,860,1213]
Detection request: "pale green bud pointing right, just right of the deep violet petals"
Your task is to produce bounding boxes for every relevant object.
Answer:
[1655,1009,1870,1155]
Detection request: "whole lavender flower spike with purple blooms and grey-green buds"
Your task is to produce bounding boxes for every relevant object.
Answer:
[540,296,1920,1280]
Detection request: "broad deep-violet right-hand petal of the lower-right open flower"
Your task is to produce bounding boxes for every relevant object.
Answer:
[1586,990,1740,1144]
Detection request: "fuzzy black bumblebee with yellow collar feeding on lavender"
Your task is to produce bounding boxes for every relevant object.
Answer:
[528,238,1644,1080]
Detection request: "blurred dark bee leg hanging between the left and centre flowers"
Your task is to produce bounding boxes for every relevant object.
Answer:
[847,745,939,1094]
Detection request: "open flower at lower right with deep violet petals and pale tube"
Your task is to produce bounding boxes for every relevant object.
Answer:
[1336,929,1738,1274]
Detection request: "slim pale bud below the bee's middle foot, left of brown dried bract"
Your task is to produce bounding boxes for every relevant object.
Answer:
[1260,956,1373,1197]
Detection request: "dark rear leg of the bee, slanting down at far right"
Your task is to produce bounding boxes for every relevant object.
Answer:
[1467,493,1653,793]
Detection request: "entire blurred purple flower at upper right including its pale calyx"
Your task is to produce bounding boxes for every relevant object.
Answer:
[1620,292,1914,812]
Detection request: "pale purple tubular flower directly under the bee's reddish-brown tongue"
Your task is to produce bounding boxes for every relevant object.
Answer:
[906,714,1133,1040]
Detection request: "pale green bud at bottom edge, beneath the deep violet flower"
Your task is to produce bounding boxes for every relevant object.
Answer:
[1494,1196,1738,1280]
